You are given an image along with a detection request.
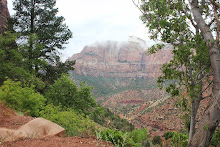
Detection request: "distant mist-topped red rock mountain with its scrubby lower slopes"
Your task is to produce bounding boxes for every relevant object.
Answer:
[68,36,183,131]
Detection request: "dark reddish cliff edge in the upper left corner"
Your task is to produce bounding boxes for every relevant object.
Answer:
[0,0,10,34]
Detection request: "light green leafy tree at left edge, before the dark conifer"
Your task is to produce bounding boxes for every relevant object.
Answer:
[0,32,44,90]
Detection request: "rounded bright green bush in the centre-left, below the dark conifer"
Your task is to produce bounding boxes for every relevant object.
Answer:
[45,74,96,114]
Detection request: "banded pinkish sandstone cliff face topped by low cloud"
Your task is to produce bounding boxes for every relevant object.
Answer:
[68,41,172,78]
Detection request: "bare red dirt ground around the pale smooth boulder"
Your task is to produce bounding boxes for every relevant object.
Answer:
[0,103,113,147]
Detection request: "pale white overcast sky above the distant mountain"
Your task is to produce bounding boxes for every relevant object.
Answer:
[8,0,153,61]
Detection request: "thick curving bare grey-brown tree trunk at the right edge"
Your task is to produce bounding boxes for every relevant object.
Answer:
[188,0,220,147]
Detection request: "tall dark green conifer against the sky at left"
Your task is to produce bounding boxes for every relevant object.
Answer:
[9,0,73,79]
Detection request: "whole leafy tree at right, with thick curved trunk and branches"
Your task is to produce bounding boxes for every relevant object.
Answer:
[133,0,220,146]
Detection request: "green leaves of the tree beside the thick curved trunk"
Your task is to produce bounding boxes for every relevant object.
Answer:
[140,0,213,142]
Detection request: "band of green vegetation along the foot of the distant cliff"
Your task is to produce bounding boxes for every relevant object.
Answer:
[69,71,157,97]
